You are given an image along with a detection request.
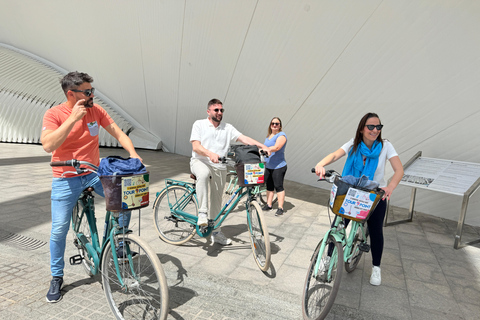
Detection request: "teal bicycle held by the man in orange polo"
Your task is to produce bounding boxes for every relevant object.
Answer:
[50,159,168,320]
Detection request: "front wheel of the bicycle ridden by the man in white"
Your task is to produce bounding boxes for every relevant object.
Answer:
[247,201,270,271]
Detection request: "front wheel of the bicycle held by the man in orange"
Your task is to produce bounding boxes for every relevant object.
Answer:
[102,234,168,319]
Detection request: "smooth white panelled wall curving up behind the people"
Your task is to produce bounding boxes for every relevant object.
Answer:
[0,0,480,225]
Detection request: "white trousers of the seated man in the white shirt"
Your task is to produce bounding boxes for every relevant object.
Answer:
[190,158,227,219]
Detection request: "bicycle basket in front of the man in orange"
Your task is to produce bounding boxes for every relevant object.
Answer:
[99,172,150,212]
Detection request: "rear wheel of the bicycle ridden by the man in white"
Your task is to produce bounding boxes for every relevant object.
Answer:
[153,186,198,245]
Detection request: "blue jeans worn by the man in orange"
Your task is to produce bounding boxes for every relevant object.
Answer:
[50,173,132,277]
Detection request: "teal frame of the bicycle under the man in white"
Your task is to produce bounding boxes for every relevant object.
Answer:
[163,179,254,237]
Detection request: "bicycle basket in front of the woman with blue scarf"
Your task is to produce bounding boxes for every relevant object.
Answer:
[329,177,384,222]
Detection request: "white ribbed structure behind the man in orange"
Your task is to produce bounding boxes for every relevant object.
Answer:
[0,45,159,147]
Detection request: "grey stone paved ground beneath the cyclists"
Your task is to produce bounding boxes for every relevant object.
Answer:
[0,143,480,320]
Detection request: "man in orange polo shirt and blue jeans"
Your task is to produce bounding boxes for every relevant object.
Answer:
[41,71,141,302]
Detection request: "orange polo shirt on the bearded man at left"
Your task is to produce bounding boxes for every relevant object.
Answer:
[42,103,114,178]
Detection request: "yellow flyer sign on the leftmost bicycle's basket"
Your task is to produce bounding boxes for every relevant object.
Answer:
[122,174,149,210]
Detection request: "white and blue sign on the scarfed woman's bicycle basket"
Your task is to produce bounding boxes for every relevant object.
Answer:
[340,188,376,219]
